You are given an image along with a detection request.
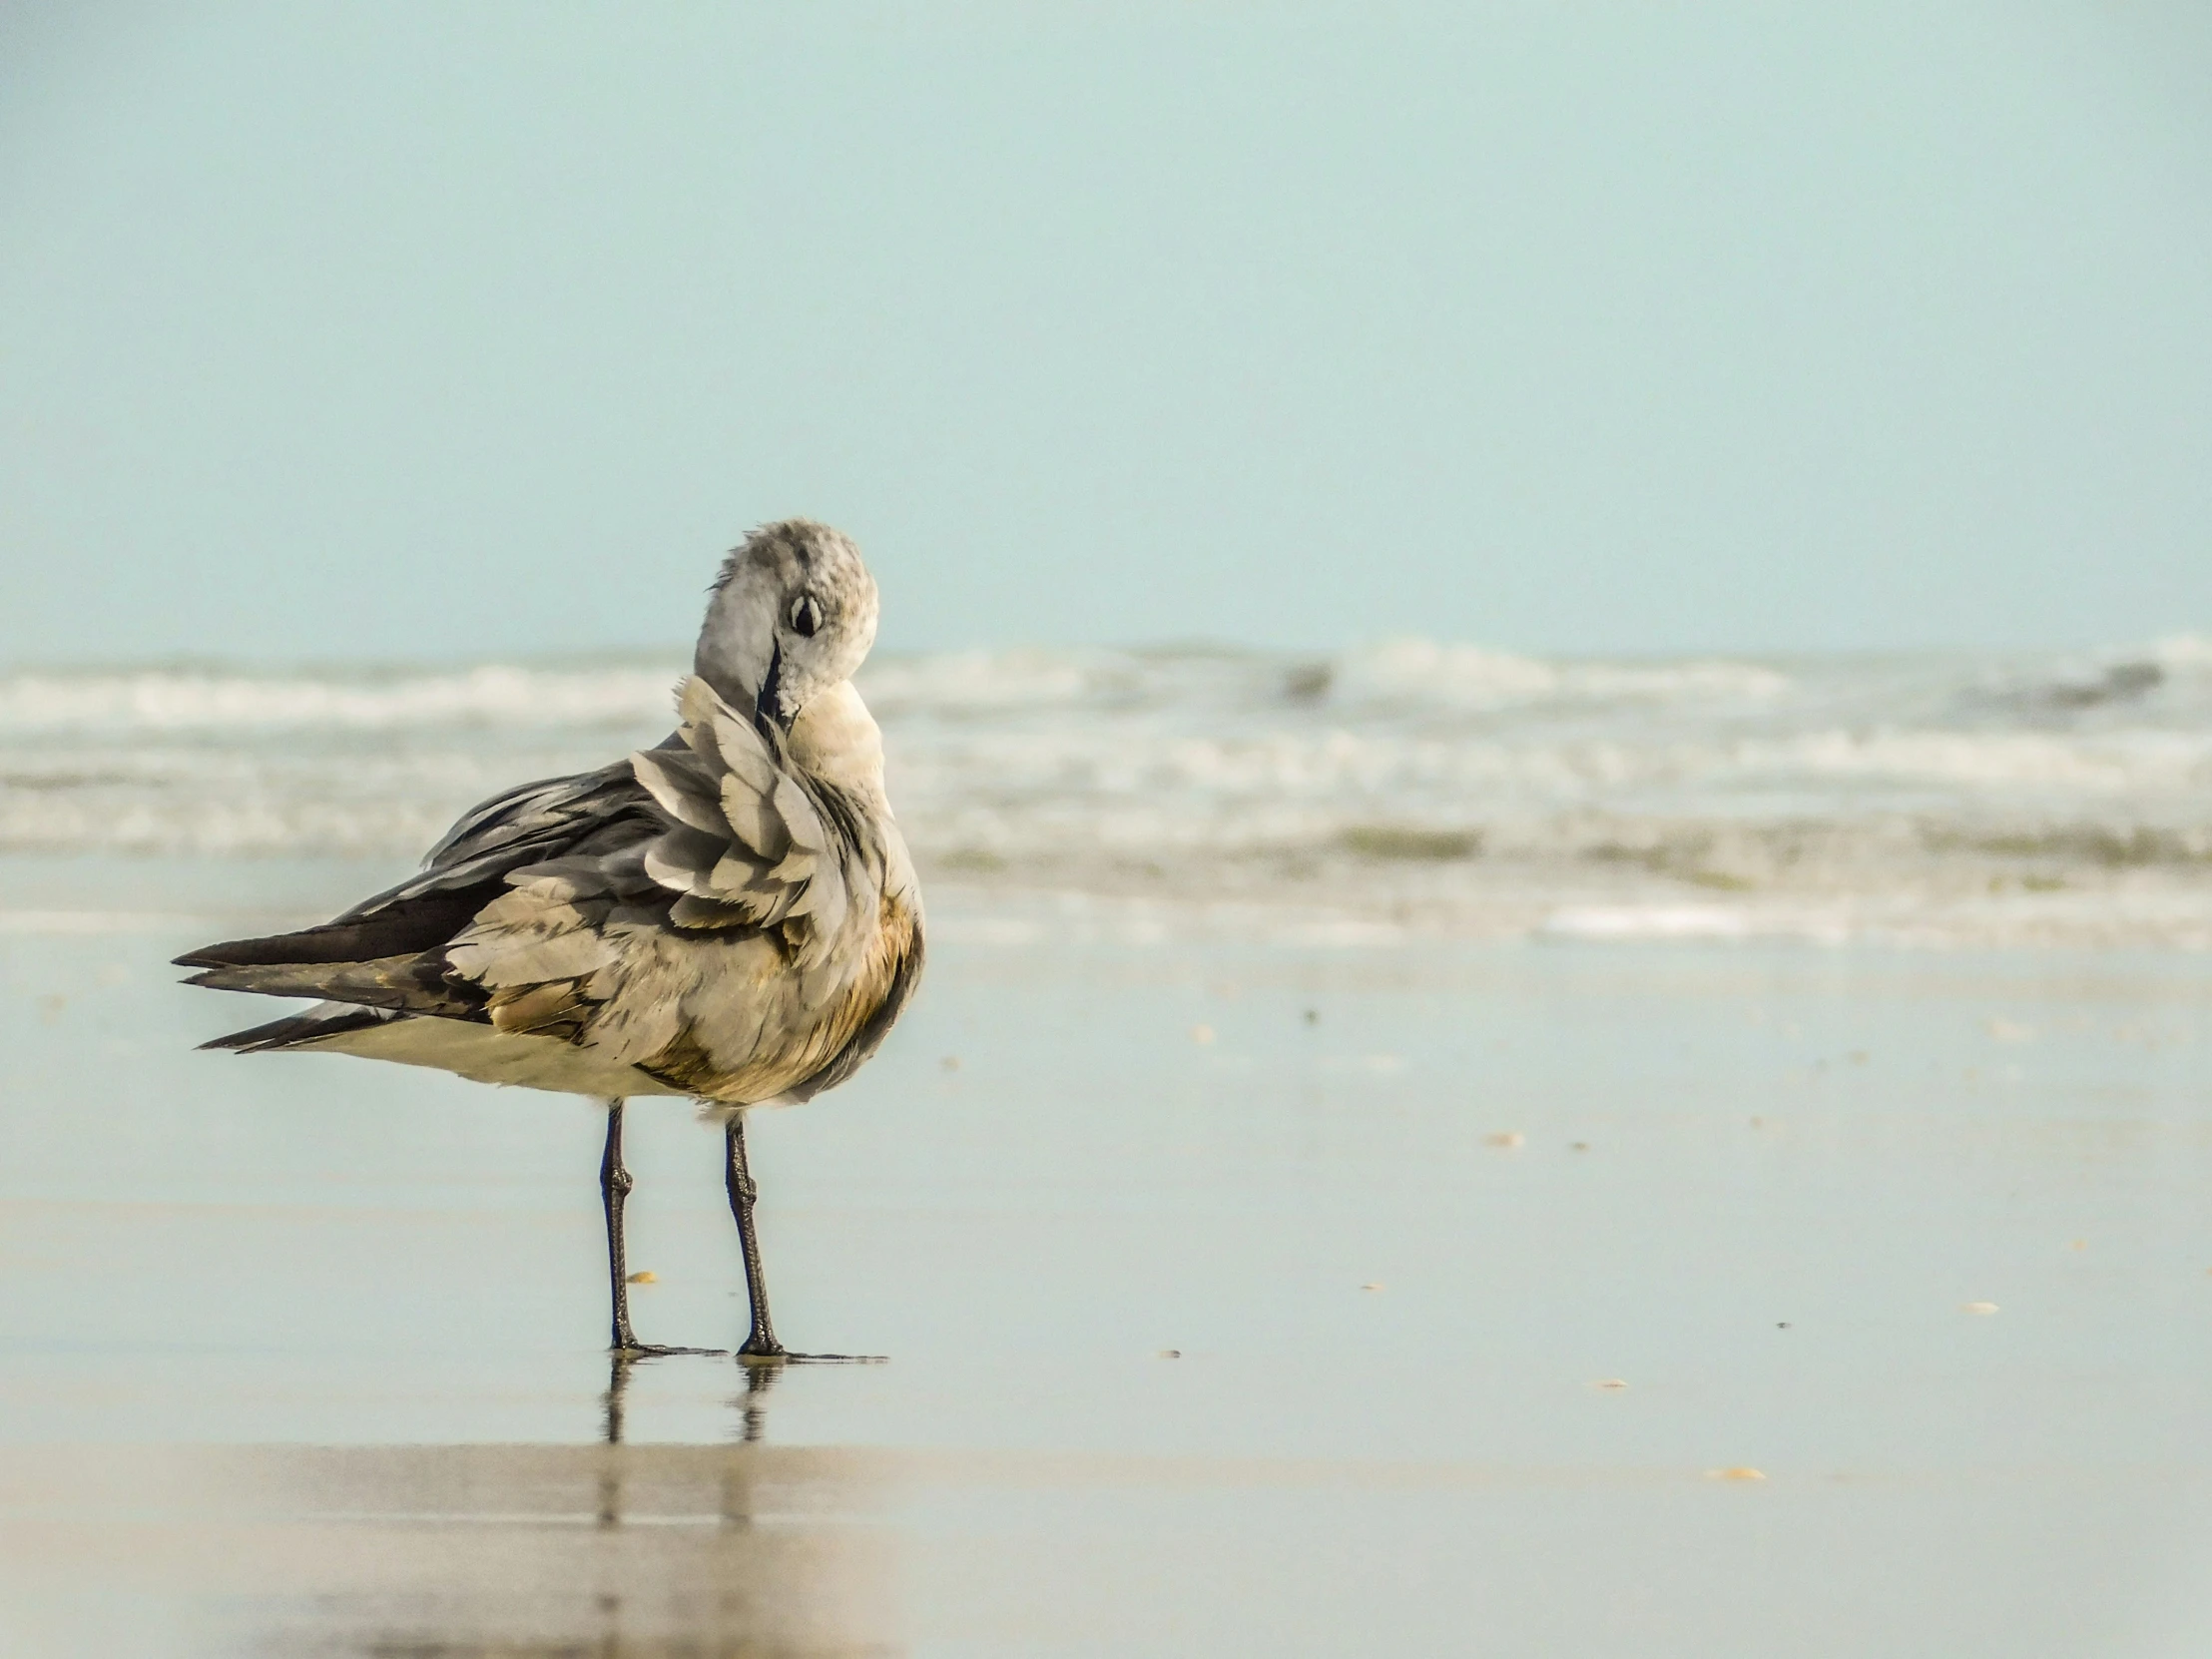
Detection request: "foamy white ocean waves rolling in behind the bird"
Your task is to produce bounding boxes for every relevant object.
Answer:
[0,635,2212,949]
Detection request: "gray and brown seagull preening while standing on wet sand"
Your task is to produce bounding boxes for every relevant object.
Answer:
[177,518,922,1363]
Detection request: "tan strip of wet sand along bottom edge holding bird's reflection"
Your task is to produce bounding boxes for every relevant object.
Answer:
[0,1444,2196,1657]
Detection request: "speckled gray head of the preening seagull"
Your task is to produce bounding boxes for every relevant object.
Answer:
[693,518,876,730]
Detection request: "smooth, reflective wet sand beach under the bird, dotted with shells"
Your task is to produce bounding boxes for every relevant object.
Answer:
[0,860,2212,1659]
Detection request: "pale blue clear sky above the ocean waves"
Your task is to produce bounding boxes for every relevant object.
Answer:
[0,0,2212,662]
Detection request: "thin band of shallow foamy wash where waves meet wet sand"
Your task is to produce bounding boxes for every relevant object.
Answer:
[0,851,2212,953]
